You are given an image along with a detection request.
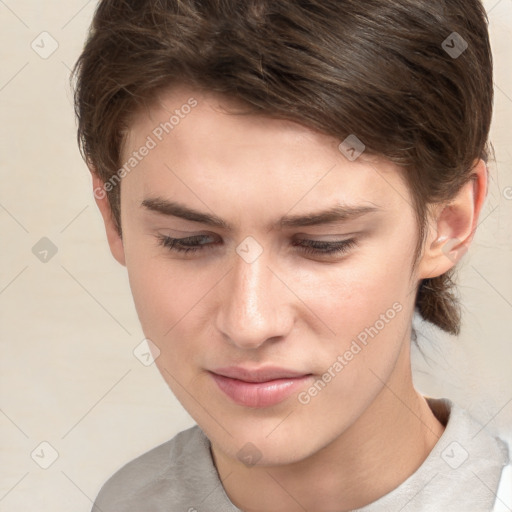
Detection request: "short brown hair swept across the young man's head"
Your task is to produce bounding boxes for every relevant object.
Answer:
[72,0,493,334]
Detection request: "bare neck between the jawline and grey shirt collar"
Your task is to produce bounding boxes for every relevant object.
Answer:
[212,344,444,512]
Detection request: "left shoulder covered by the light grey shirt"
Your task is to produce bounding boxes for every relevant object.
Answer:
[92,425,210,512]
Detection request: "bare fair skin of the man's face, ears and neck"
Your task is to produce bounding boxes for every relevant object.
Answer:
[91,85,487,512]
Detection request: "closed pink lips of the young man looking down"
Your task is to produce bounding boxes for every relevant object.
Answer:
[209,366,313,408]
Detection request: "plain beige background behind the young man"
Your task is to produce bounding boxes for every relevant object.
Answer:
[0,0,512,512]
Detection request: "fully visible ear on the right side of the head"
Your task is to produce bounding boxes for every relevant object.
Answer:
[418,160,488,279]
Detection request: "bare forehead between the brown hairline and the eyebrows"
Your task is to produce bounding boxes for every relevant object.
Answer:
[118,86,407,220]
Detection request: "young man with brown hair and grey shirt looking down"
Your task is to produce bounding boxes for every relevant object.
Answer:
[71,0,510,512]
